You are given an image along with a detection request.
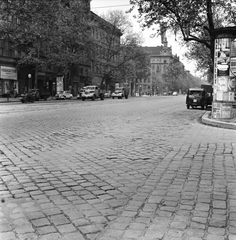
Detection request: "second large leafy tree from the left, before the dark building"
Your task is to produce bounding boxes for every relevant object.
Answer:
[46,0,93,88]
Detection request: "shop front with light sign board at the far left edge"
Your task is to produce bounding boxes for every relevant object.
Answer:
[0,66,19,97]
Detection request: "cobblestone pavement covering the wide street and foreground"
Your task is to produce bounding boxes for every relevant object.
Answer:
[0,96,236,240]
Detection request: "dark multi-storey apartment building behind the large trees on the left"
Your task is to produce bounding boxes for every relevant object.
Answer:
[0,0,121,96]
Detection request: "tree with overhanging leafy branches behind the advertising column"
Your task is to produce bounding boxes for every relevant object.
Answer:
[130,0,236,75]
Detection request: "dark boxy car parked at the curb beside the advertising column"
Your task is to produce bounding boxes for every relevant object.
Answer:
[186,88,208,109]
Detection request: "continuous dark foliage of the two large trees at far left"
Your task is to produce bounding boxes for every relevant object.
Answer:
[0,0,91,86]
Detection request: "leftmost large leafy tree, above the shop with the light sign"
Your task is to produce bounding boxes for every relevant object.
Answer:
[0,0,58,87]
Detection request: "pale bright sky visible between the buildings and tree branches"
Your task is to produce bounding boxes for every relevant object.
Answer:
[91,0,198,75]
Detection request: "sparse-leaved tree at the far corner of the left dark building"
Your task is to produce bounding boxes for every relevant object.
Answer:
[91,10,145,88]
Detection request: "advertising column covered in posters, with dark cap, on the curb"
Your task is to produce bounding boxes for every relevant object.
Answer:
[212,29,236,119]
